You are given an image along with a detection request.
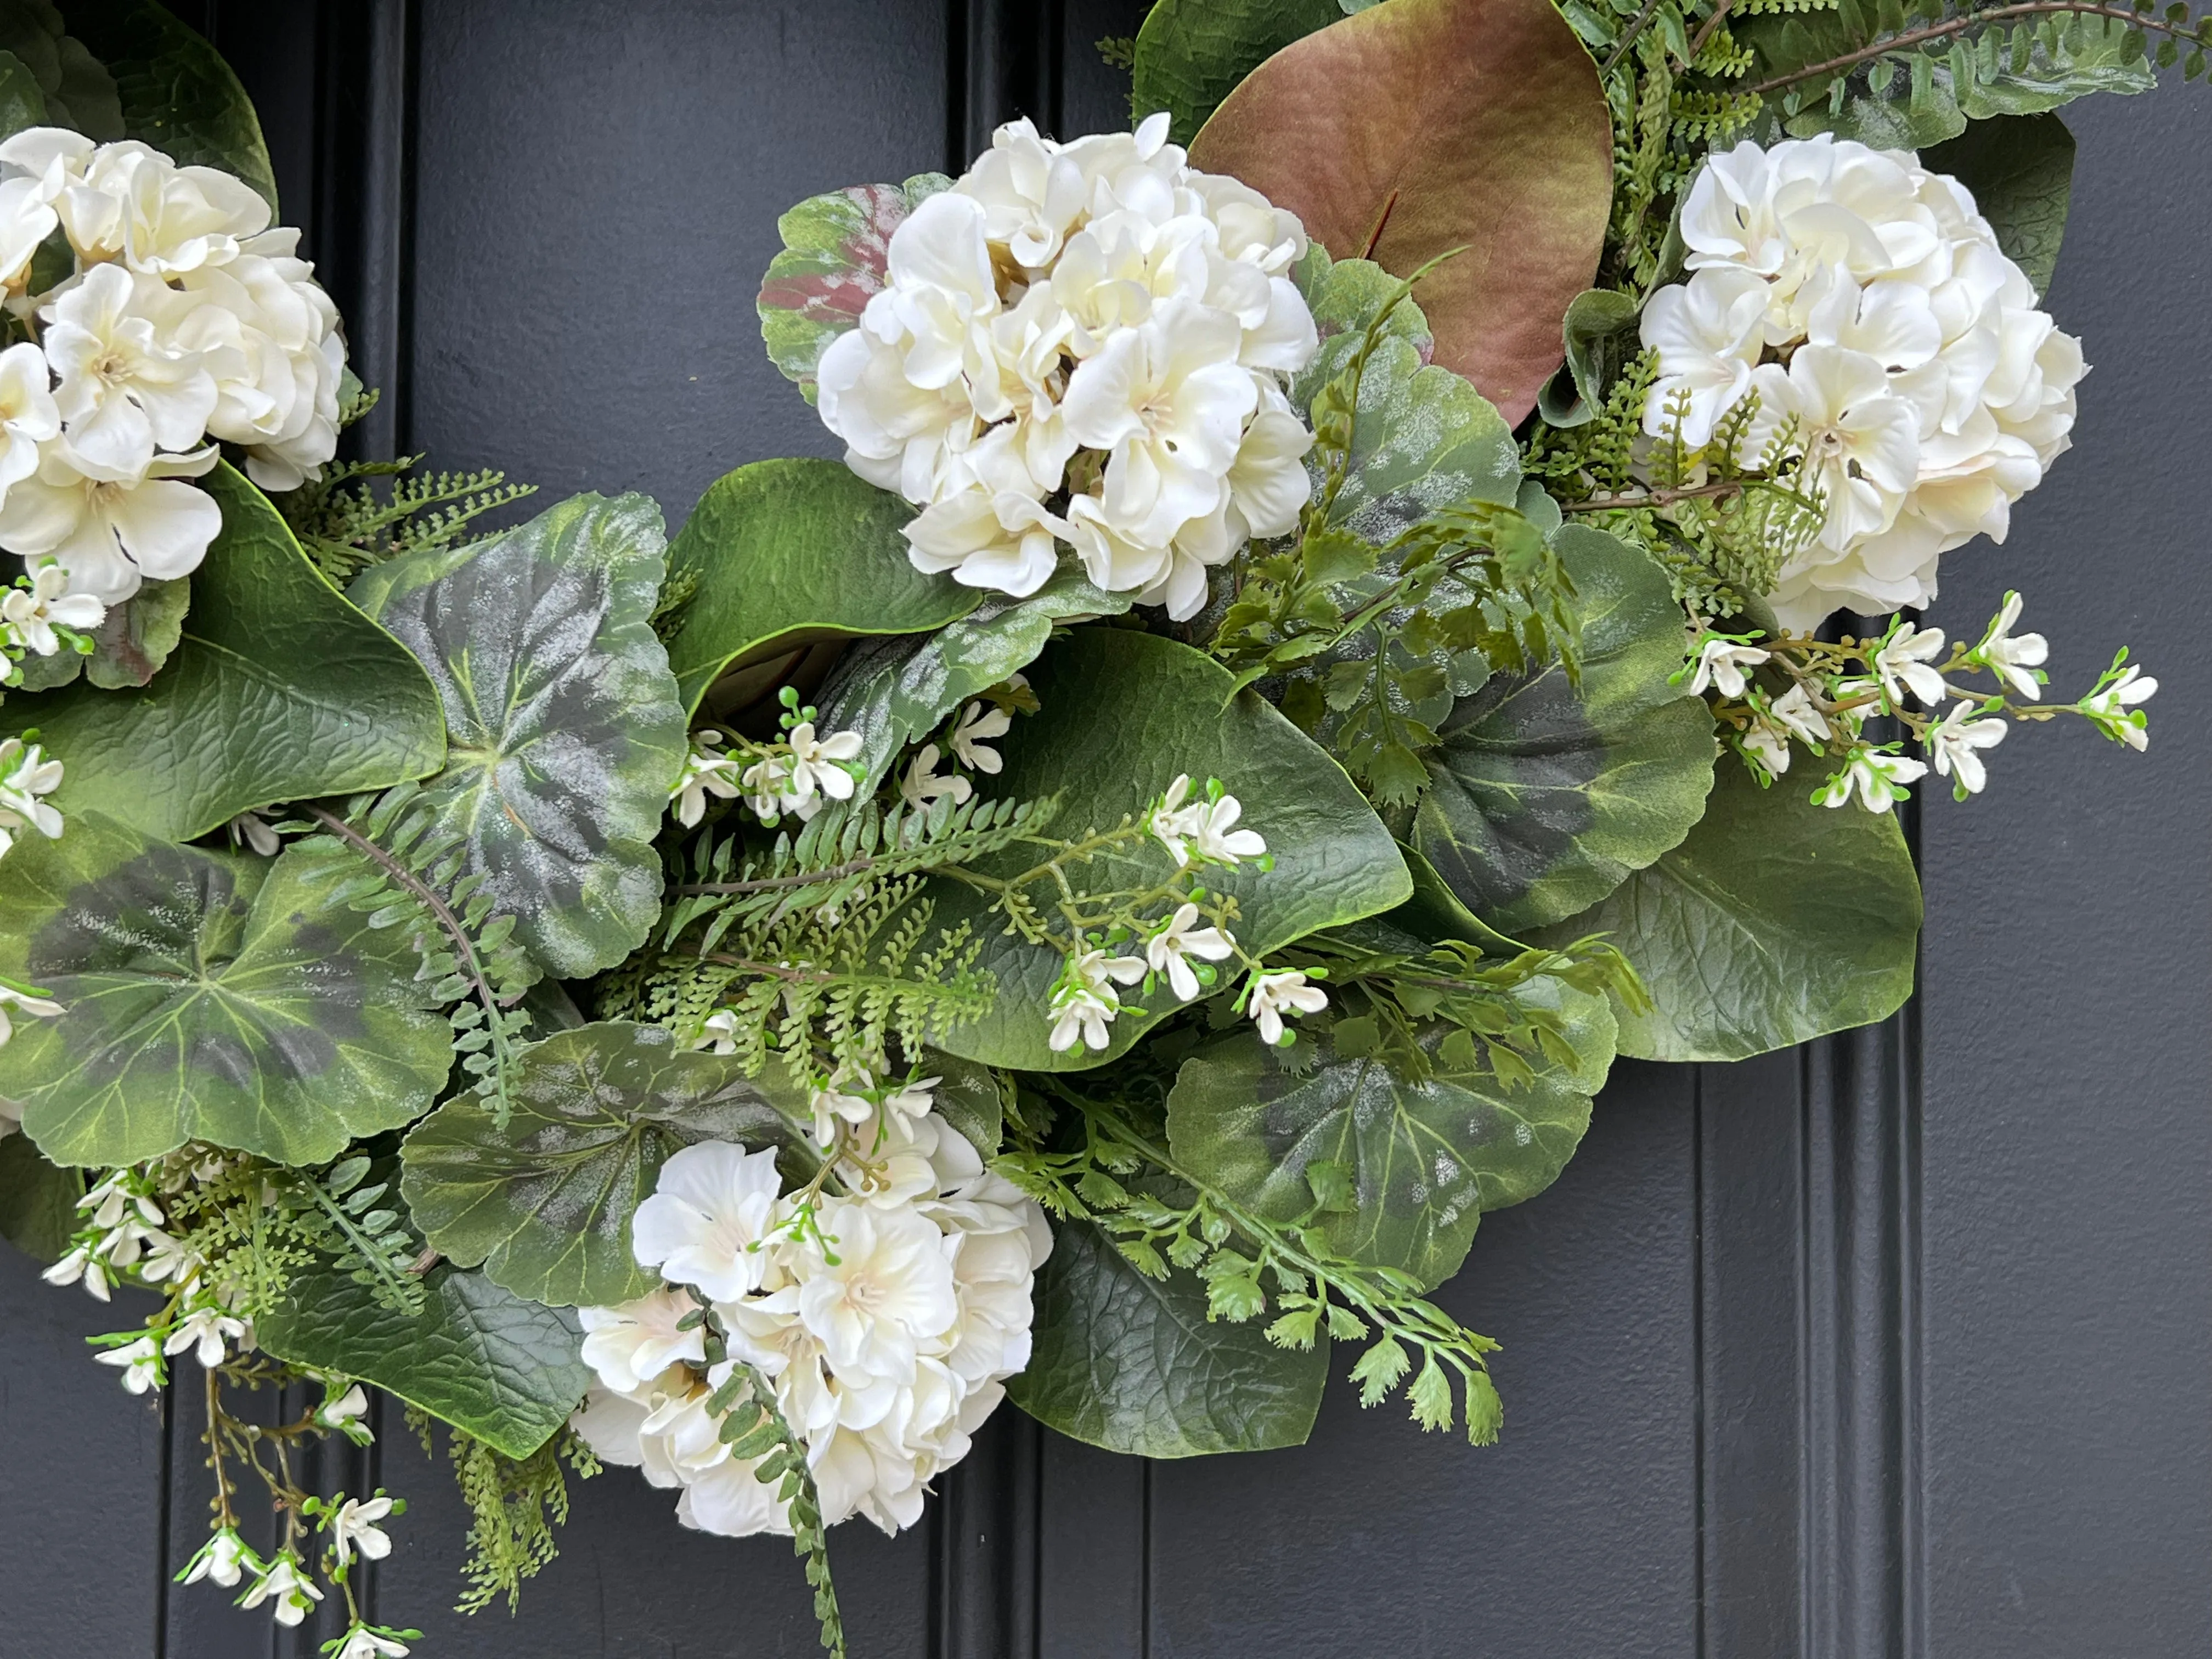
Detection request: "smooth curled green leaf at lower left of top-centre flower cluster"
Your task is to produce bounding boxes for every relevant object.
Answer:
[650,460,982,712]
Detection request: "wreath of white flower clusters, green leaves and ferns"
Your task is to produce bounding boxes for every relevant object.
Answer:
[0,0,2176,1659]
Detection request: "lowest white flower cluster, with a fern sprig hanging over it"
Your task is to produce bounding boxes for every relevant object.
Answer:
[575,1097,1053,1537]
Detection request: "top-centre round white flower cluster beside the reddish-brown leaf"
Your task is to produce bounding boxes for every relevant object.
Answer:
[819,115,1316,619]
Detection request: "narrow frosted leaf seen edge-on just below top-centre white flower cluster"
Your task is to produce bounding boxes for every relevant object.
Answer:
[816,566,1130,789]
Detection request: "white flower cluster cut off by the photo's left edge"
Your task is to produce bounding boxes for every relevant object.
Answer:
[0,126,345,610]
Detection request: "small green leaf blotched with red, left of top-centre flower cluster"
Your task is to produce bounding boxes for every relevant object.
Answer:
[759,172,951,403]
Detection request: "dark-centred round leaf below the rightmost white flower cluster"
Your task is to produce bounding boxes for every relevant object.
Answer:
[1413,524,1714,934]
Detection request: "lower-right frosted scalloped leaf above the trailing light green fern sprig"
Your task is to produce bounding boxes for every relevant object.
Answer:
[1168,1013,1612,1290]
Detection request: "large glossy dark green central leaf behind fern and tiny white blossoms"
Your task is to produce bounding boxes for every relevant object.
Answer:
[927,628,1413,1070]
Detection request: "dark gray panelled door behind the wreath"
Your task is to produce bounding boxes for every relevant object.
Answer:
[0,0,2212,1659]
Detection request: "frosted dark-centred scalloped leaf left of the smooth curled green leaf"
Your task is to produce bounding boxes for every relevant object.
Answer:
[352,495,686,980]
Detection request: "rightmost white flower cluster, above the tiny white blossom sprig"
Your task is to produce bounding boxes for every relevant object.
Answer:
[1644,133,2086,628]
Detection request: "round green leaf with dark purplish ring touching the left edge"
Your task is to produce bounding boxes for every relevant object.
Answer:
[0,814,454,1164]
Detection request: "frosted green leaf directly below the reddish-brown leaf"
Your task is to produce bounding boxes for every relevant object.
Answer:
[1290,255,1522,546]
